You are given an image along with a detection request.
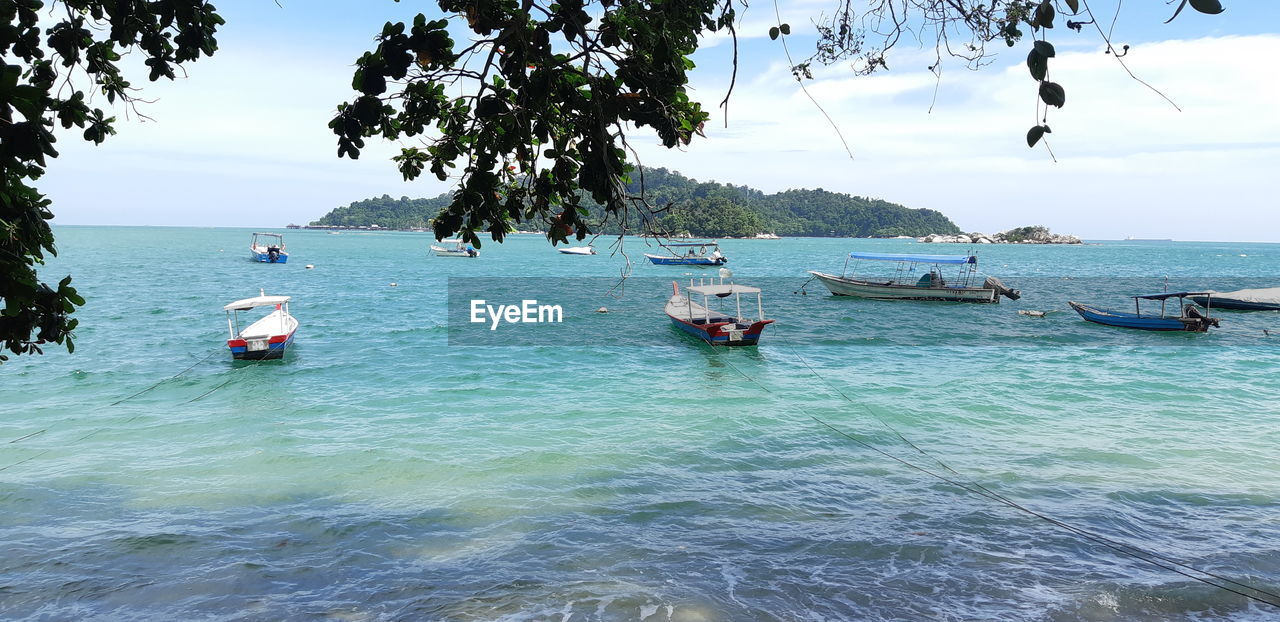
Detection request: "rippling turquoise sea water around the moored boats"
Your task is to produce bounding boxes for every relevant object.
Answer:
[0,227,1280,621]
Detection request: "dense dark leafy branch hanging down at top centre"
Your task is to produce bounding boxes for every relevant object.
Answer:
[329,0,735,246]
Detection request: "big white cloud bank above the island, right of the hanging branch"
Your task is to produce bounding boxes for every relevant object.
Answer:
[627,36,1280,239]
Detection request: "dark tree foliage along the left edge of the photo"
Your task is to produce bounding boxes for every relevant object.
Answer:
[0,0,223,361]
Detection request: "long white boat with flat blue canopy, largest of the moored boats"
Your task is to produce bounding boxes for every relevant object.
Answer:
[809,252,1021,302]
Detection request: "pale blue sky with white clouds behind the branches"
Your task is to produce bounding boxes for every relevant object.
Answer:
[38,0,1280,242]
